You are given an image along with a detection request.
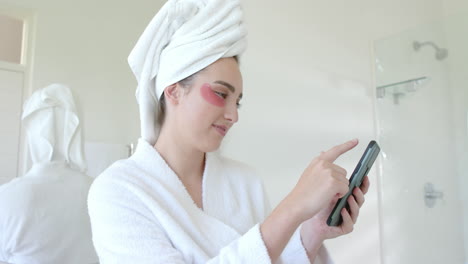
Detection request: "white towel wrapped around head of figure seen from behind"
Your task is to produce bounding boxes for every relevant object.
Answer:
[22,84,86,172]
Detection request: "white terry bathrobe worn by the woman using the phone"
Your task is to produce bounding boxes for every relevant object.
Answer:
[88,140,331,264]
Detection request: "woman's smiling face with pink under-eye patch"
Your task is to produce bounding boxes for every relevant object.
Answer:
[176,58,243,152]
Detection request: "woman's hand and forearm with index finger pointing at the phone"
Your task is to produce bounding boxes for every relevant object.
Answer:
[260,140,358,262]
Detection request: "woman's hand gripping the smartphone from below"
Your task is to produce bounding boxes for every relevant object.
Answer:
[301,176,370,252]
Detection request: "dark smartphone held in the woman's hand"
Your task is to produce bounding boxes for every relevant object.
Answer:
[327,140,380,226]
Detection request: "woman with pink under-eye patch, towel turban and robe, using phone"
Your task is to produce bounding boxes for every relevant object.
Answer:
[88,0,369,263]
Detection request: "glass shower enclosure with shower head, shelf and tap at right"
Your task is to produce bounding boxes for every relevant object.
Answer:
[374,11,468,264]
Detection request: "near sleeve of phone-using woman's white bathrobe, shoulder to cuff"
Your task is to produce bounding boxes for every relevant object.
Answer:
[88,174,271,264]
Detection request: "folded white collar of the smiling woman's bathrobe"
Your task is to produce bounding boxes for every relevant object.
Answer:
[130,139,242,250]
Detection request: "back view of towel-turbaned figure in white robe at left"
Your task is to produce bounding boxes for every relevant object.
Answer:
[0,84,97,264]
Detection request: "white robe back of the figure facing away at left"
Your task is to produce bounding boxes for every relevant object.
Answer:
[0,161,97,264]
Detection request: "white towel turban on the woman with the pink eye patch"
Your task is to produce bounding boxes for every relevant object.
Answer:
[128,0,247,145]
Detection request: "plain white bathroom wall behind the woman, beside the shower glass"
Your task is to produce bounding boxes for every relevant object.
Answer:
[0,0,460,264]
